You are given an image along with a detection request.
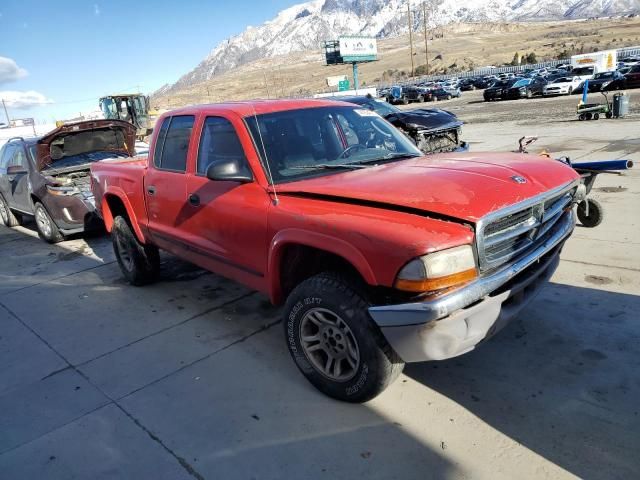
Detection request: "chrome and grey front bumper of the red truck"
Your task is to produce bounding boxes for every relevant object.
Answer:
[369,211,575,362]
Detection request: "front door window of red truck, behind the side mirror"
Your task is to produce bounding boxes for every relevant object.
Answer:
[197,117,248,174]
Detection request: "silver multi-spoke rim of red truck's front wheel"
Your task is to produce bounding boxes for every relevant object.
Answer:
[300,308,360,382]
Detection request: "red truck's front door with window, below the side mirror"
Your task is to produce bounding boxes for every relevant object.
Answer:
[183,116,270,288]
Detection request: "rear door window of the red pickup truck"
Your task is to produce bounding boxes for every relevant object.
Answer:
[153,115,194,172]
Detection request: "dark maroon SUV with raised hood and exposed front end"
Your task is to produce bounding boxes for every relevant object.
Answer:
[0,120,136,243]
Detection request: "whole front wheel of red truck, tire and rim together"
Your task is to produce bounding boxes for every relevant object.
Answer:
[284,273,404,403]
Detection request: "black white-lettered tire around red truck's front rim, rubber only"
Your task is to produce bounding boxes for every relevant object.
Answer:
[284,273,404,403]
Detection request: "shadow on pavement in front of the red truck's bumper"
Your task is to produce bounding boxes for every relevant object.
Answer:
[405,284,640,478]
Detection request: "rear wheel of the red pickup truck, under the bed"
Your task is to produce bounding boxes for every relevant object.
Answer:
[111,216,160,286]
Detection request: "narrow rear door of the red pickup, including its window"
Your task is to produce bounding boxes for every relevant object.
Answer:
[144,115,195,251]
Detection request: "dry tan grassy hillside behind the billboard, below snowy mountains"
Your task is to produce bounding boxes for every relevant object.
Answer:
[152,18,640,110]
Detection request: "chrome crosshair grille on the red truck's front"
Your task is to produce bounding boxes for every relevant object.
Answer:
[476,183,576,272]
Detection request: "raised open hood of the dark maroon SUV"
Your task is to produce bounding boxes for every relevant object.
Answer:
[36,120,136,170]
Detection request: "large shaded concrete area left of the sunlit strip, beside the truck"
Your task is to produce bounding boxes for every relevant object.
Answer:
[0,227,460,480]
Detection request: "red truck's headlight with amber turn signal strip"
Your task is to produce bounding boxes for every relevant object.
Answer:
[395,245,478,292]
